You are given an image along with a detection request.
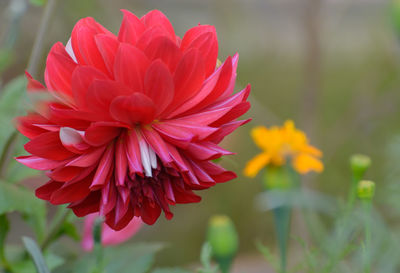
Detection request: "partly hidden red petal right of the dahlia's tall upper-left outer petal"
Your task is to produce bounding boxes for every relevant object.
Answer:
[94,34,119,75]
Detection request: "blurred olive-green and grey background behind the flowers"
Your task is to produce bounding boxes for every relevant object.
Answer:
[0,0,400,265]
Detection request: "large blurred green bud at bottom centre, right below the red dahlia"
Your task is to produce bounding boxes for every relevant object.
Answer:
[207,215,239,272]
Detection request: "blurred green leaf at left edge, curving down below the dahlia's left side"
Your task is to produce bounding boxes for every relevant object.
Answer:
[0,180,46,240]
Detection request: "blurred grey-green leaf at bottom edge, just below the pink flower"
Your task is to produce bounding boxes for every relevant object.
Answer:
[104,243,164,273]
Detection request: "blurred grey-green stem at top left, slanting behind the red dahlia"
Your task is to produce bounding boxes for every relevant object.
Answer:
[28,0,57,77]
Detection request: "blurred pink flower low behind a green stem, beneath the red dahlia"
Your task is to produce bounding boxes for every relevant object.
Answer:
[81,213,142,251]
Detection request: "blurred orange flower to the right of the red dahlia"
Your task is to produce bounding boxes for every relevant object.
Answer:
[244,120,324,177]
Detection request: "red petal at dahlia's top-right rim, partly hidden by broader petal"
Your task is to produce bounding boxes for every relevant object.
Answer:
[181,29,218,76]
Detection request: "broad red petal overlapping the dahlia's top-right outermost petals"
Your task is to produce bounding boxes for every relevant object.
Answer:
[168,49,205,113]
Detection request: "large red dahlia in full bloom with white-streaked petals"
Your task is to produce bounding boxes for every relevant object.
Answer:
[17,10,250,227]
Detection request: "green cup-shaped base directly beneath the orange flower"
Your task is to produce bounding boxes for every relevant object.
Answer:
[263,166,293,190]
